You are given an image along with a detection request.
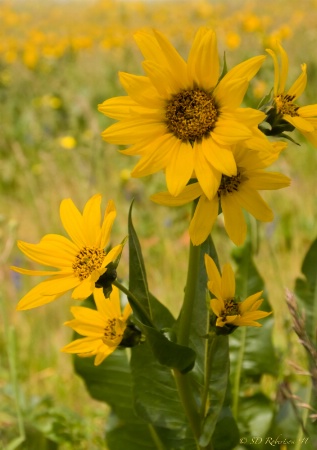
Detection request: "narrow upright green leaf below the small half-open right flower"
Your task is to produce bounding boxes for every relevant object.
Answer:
[199,336,229,446]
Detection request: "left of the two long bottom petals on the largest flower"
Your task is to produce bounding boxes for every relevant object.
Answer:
[166,141,194,197]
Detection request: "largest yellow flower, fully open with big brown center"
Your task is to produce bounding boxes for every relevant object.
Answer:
[98,27,265,199]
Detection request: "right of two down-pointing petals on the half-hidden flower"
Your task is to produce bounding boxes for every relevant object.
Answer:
[221,195,247,245]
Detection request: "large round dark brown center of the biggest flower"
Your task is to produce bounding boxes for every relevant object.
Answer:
[166,88,219,142]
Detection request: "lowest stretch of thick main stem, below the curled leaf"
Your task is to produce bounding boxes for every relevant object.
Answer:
[173,369,200,448]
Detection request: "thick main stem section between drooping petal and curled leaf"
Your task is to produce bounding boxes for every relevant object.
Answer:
[177,243,200,345]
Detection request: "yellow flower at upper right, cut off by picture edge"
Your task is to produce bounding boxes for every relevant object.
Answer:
[266,42,317,146]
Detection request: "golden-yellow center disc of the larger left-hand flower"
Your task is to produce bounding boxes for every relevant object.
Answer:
[72,247,105,281]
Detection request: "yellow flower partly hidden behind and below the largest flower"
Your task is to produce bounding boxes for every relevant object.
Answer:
[151,140,290,245]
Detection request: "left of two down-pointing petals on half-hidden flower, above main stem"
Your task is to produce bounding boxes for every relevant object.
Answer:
[189,195,219,245]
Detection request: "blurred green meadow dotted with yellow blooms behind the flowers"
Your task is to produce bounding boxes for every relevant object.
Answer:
[0,0,317,450]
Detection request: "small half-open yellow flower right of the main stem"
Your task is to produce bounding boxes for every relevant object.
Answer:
[205,255,271,327]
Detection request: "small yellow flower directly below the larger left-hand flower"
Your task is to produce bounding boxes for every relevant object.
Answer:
[62,287,132,366]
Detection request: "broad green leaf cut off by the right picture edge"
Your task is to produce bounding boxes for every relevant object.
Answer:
[295,239,317,344]
